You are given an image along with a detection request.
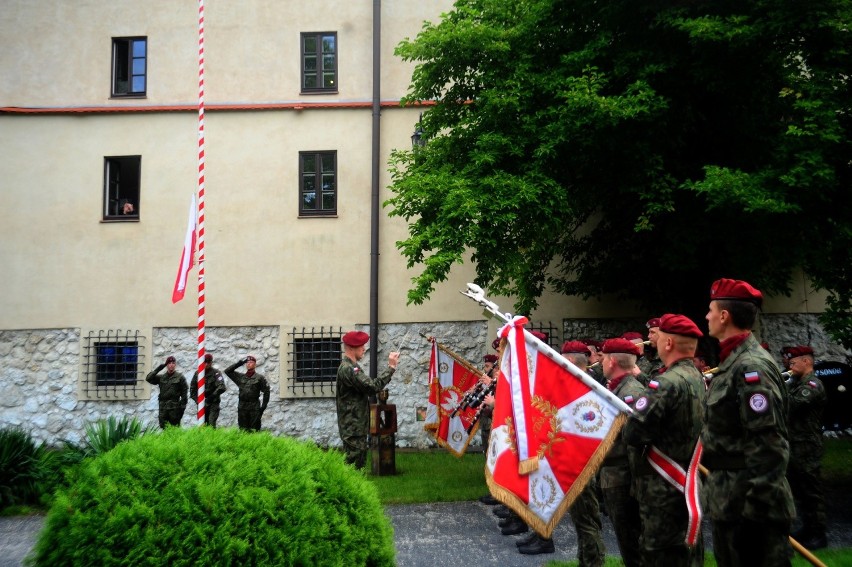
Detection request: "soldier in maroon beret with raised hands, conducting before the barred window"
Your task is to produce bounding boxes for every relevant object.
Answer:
[337,331,399,469]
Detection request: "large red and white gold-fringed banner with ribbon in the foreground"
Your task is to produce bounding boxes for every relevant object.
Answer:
[485,317,630,537]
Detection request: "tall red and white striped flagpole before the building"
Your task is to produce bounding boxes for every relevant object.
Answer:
[197,0,205,425]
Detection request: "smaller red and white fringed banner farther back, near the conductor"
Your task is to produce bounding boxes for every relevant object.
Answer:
[423,338,481,457]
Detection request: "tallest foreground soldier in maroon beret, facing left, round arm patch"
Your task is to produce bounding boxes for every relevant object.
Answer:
[701,279,794,567]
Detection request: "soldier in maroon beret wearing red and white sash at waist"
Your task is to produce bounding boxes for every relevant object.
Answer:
[624,314,704,567]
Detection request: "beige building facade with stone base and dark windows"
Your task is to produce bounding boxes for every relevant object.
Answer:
[0,0,836,446]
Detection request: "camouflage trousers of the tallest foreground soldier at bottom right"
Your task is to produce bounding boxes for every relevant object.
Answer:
[713,520,790,567]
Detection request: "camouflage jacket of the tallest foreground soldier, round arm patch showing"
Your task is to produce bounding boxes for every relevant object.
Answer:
[701,333,794,523]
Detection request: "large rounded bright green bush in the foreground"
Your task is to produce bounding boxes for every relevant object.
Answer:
[30,427,394,566]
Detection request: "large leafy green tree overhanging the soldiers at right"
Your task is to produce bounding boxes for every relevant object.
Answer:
[385,0,852,346]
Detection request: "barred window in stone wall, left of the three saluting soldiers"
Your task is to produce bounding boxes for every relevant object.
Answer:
[82,329,146,399]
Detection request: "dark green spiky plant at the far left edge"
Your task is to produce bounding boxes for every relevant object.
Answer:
[0,427,44,509]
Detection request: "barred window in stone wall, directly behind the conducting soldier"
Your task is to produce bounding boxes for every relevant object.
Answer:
[287,327,343,397]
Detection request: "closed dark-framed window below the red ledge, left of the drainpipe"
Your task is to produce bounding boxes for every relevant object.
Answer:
[299,151,337,216]
